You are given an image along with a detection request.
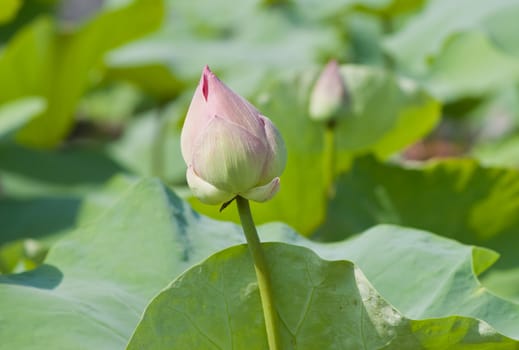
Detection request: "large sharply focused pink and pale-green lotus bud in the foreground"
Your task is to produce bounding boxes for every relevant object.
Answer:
[181,66,286,204]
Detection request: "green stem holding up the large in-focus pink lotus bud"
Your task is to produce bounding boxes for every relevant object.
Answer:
[236,196,280,350]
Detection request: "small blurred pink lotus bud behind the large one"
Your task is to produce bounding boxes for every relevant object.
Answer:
[309,60,349,122]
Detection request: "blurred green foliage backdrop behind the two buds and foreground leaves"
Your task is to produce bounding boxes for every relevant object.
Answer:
[0,0,519,297]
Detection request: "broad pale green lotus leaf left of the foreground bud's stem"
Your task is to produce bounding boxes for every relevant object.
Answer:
[0,180,242,349]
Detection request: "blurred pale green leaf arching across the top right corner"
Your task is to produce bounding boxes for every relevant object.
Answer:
[385,0,519,73]
